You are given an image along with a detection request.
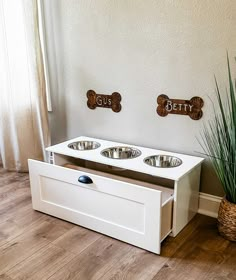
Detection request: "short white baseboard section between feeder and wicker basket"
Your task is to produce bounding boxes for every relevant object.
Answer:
[198,192,222,218]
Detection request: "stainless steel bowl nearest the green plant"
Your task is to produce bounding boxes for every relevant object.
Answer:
[144,155,182,168]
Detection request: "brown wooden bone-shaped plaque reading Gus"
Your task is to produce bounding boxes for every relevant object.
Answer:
[87,90,121,113]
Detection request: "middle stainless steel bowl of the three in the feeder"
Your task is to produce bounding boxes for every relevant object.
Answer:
[101,147,141,159]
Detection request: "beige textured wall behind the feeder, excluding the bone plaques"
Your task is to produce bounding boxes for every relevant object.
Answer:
[44,0,236,195]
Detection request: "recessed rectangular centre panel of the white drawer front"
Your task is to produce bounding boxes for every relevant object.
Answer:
[40,176,145,233]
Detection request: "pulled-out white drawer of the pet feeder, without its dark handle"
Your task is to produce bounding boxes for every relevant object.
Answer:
[29,160,173,253]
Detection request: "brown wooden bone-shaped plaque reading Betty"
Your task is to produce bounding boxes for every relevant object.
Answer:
[157,94,204,120]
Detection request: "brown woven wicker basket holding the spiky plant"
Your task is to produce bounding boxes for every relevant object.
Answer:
[218,197,236,241]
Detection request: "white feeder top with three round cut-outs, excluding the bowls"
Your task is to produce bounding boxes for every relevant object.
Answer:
[46,136,204,181]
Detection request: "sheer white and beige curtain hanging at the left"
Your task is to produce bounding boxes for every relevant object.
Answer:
[0,0,50,171]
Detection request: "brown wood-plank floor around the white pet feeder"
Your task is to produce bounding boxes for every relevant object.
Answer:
[0,168,236,280]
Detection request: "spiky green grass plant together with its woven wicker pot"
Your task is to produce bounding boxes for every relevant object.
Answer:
[200,55,236,241]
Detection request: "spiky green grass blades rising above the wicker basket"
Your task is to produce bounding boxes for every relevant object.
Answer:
[201,55,236,203]
